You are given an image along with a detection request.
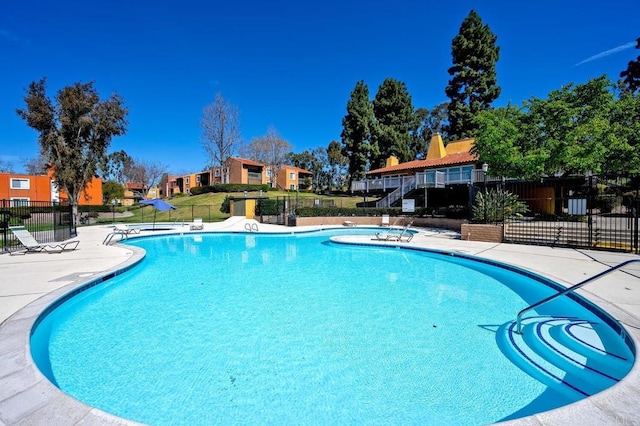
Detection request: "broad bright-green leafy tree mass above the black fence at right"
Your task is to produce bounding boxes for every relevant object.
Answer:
[474,76,640,179]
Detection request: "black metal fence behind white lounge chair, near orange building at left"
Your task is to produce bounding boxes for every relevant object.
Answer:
[0,200,76,252]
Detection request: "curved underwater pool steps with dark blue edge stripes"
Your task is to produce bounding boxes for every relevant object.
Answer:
[496,316,633,399]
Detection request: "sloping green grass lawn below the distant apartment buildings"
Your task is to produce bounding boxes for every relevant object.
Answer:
[92,191,363,223]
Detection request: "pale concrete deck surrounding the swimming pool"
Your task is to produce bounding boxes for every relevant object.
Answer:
[0,218,640,426]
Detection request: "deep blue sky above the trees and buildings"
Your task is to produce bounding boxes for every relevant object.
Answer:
[0,0,640,173]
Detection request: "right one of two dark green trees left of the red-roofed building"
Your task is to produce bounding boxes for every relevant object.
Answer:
[371,78,418,168]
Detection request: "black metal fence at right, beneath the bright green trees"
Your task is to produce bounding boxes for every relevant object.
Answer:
[488,176,640,253]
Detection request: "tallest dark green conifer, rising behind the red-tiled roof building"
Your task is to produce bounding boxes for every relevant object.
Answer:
[445,10,500,139]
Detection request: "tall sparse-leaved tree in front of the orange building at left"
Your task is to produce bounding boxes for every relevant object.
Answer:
[17,79,128,223]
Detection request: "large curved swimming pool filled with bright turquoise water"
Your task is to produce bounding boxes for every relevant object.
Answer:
[32,231,636,424]
